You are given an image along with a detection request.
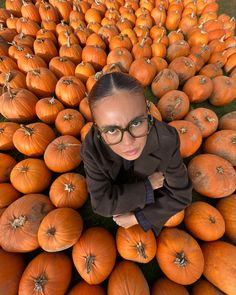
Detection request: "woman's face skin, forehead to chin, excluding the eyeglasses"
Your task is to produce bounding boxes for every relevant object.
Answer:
[93,90,147,161]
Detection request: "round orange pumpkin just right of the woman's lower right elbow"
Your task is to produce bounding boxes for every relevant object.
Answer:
[184,201,225,241]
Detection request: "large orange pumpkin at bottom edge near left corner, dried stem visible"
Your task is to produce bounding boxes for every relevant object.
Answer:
[18,252,72,295]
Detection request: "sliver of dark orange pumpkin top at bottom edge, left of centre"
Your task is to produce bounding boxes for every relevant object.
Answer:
[68,281,106,295]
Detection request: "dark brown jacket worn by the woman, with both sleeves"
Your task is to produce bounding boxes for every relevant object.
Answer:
[81,121,192,235]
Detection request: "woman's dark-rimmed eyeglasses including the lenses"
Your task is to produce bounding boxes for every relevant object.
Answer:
[94,115,153,145]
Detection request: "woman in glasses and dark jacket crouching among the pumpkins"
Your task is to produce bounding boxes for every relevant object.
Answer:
[81,72,192,236]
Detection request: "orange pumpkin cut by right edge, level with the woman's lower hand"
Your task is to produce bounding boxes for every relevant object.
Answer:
[216,194,236,244]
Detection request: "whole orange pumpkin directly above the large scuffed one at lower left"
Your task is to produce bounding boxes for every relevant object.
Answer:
[10,158,52,194]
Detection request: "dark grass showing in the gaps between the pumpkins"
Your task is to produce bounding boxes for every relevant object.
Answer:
[0,0,236,287]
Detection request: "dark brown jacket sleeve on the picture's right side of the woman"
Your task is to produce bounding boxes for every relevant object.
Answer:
[135,131,192,235]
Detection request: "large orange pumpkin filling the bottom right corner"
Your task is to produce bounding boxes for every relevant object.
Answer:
[201,241,236,295]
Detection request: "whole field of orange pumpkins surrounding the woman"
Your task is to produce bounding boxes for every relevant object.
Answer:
[0,0,236,295]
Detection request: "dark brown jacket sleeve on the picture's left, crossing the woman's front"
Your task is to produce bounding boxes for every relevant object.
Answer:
[82,153,154,217]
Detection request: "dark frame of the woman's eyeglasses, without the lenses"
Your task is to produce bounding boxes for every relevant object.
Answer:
[93,114,154,145]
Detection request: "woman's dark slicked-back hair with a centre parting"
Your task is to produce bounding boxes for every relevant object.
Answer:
[88,72,144,112]
